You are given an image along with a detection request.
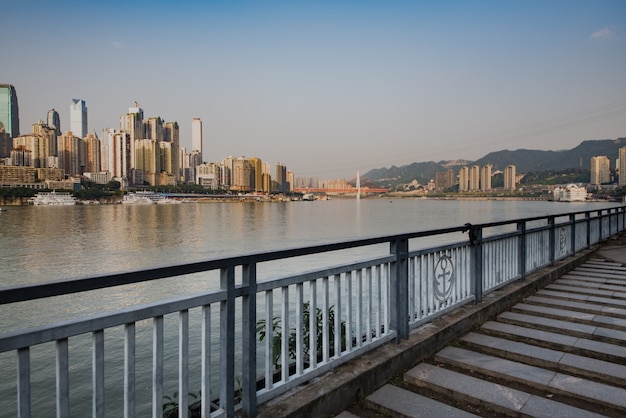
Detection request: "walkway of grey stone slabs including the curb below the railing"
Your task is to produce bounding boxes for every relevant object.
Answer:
[259,234,626,418]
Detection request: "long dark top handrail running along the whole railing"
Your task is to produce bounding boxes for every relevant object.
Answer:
[0,206,625,305]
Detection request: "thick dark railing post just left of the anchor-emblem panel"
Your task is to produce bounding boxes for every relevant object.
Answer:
[390,238,409,342]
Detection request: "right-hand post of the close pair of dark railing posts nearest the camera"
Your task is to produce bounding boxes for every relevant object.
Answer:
[241,263,256,417]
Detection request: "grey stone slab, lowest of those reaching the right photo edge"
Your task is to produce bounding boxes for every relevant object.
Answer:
[428,346,626,416]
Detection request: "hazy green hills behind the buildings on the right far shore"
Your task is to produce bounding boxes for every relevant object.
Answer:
[361,138,626,187]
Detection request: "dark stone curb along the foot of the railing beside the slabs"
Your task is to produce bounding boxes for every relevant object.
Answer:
[258,243,603,418]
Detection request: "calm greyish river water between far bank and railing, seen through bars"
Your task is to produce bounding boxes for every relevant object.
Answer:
[0,199,616,417]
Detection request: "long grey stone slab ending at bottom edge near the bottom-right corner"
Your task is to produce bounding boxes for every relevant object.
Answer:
[404,363,602,418]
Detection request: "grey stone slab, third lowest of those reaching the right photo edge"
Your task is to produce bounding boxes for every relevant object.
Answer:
[480,321,626,364]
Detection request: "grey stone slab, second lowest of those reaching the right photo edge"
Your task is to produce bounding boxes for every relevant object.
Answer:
[461,332,626,387]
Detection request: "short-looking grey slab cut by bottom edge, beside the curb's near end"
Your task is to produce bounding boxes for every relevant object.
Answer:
[364,385,477,418]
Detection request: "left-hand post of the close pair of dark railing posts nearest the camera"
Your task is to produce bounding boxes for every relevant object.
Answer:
[222,265,235,417]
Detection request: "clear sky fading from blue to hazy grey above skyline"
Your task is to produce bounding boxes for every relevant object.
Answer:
[0,0,626,178]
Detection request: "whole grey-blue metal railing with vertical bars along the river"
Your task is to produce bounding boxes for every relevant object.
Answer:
[0,207,626,417]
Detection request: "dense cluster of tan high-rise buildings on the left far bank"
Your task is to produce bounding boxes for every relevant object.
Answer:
[0,84,302,193]
